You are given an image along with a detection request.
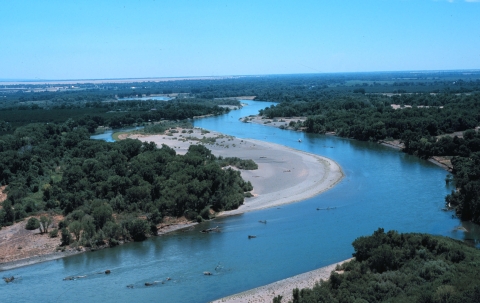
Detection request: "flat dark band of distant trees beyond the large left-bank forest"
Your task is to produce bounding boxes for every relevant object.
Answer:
[0,99,234,134]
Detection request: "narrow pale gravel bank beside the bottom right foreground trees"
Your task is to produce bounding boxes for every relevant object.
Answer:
[212,259,352,303]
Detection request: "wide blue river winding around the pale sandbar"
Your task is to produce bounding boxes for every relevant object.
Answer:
[0,101,476,302]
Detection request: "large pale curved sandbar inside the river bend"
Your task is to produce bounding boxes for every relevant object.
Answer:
[130,129,343,216]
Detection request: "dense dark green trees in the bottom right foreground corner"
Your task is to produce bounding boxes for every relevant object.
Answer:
[273,228,480,303]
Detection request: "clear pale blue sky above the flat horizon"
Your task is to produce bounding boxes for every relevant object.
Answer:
[0,0,480,80]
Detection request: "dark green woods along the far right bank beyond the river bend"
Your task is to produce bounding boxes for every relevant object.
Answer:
[260,94,480,141]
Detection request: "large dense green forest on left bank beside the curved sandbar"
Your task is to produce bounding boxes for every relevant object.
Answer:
[0,101,256,246]
